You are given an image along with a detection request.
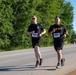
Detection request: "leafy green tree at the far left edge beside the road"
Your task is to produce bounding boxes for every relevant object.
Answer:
[0,1,14,49]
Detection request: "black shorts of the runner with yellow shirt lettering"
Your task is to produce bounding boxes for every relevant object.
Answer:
[54,39,64,51]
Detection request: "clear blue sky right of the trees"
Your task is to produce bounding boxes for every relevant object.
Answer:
[66,0,76,32]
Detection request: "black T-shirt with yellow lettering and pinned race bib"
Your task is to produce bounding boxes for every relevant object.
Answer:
[48,24,67,39]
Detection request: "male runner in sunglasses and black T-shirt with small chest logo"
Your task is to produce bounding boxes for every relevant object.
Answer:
[28,15,46,67]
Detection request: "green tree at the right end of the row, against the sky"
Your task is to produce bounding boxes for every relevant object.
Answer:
[61,2,74,42]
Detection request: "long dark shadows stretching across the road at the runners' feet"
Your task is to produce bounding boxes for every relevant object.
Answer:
[0,65,56,72]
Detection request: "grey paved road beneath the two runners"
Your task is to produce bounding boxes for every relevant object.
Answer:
[0,44,76,75]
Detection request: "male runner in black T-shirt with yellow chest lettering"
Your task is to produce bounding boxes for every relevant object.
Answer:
[48,16,68,68]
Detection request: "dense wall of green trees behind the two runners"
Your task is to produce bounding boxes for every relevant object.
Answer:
[0,0,73,50]
